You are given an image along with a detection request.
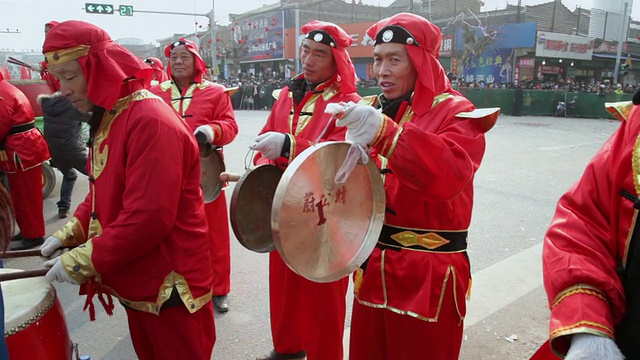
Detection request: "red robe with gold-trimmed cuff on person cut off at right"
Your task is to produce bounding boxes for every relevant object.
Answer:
[539,102,640,359]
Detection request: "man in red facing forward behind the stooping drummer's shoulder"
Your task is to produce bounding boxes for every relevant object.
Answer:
[151,39,238,312]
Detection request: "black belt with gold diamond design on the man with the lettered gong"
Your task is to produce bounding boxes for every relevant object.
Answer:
[376,225,468,252]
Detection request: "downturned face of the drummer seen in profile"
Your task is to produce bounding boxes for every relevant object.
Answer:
[49,60,95,113]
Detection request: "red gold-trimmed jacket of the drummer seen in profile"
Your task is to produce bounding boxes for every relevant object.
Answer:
[54,83,212,315]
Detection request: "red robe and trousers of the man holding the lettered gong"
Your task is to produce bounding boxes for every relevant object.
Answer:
[349,93,499,360]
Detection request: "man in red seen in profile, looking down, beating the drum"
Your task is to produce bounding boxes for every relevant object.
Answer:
[42,21,215,360]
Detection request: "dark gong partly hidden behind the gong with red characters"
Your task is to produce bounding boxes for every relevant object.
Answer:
[229,165,282,253]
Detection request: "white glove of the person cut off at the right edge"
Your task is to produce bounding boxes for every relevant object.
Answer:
[565,334,624,360]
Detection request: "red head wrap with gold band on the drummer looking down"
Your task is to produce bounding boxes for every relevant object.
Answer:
[43,20,153,110]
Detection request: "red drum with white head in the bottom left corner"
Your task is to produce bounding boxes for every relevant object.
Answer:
[0,269,73,360]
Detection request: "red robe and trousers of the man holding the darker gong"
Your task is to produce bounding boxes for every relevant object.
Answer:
[256,75,360,360]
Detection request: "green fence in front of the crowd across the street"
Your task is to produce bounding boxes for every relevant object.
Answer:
[358,87,633,119]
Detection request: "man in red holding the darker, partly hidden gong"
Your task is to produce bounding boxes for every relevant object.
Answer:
[252,21,360,360]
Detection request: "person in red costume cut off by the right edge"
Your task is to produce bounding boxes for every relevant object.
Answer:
[532,100,640,360]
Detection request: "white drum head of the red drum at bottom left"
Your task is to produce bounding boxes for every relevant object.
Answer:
[0,268,56,337]
